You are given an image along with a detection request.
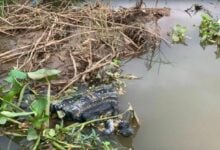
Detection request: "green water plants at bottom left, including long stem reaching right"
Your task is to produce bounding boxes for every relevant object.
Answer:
[0,69,138,150]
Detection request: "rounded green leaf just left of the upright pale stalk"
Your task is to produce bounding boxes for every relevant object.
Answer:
[31,97,47,116]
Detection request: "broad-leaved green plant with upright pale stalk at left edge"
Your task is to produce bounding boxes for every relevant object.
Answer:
[0,69,60,149]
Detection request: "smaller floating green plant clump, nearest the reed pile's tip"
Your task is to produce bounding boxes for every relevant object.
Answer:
[171,24,187,43]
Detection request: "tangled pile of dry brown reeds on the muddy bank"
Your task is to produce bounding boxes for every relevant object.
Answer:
[0,4,169,91]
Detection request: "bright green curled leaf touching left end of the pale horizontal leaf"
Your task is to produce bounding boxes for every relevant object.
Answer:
[5,69,27,83]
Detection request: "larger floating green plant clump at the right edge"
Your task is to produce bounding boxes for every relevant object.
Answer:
[199,14,220,58]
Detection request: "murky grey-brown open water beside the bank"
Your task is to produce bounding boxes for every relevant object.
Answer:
[121,1,220,150]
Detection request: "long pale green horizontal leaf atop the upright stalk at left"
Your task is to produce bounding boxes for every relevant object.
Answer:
[28,69,60,80]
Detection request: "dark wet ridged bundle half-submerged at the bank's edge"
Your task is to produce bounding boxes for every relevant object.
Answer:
[51,85,118,122]
